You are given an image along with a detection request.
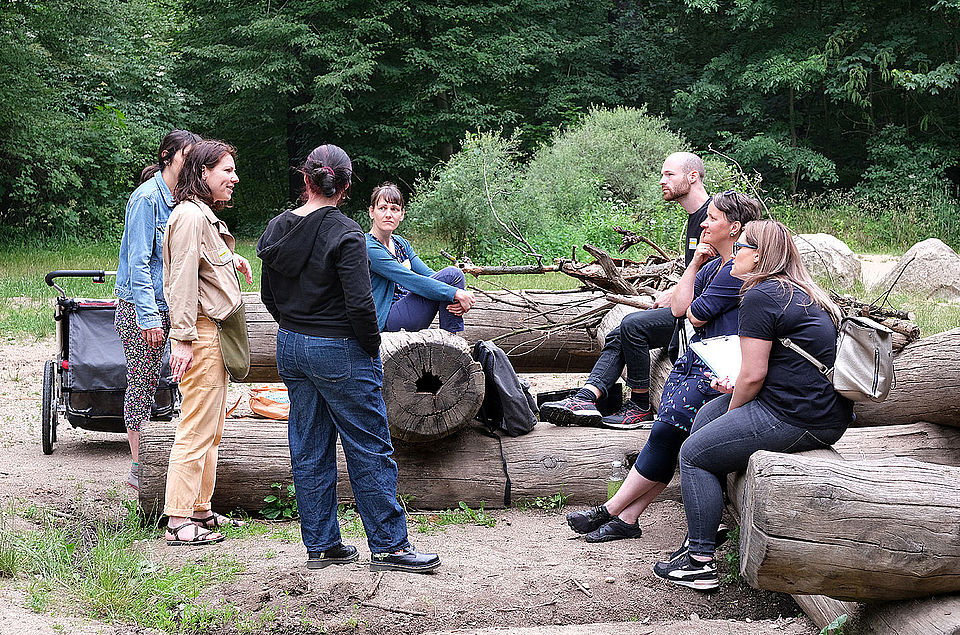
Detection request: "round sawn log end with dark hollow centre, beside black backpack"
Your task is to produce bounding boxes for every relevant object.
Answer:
[380,329,484,443]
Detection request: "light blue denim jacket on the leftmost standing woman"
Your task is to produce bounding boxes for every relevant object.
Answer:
[113,172,173,329]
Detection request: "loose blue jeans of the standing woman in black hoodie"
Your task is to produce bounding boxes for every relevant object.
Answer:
[277,329,410,553]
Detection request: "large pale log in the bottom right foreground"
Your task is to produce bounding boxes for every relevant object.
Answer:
[731,452,960,600]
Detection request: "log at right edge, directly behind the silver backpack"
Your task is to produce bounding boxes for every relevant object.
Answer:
[854,328,960,426]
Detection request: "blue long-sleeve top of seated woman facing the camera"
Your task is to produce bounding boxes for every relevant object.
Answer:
[366,233,457,331]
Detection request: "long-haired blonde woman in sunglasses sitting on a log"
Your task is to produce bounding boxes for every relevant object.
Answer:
[654,220,853,590]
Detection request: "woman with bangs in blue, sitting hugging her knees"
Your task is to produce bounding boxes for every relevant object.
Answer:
[366,183,475,333]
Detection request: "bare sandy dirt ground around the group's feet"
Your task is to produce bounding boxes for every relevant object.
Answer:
[0,340,817,635]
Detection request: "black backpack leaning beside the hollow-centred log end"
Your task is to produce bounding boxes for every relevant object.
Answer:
[473,340,539,437]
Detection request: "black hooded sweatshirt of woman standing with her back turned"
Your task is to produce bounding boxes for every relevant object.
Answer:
[257,207,380,357]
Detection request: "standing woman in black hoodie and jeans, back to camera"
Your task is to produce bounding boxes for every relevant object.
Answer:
[257,145,440,572]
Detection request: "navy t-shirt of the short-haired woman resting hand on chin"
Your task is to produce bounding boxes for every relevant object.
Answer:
[690,257,743,342]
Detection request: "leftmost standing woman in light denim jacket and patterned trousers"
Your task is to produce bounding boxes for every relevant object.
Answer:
[114,130,200,489]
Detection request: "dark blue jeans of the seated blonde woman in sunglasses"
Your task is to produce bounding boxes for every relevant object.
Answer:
[680,395,847,557]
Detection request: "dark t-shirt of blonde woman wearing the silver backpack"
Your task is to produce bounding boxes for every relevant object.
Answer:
[740,280,853,429]
